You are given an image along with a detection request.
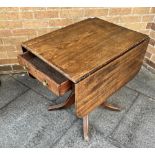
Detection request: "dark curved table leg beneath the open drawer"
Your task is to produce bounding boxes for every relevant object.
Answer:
[48,93,75,111]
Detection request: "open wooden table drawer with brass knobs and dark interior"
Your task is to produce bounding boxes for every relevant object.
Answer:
[18,52,72,96]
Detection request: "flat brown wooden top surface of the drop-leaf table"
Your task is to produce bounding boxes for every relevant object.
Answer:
[22,18,148,83]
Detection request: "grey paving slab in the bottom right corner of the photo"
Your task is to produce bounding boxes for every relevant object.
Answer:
[111,95,155,148]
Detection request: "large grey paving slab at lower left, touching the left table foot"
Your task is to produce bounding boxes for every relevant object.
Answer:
[0,90,77,147]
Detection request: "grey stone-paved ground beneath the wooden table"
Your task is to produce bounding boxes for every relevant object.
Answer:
[0,67,155,147]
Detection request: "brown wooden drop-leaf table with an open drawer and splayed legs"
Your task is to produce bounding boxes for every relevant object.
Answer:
[18,18,149,140]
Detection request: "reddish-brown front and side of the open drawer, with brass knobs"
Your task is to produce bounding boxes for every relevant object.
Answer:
[18,53,72,96]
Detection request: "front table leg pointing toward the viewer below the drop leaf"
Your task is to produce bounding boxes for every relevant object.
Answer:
[83,115,89,141]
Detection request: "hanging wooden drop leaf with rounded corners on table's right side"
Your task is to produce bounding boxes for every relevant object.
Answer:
[75,38,149,117]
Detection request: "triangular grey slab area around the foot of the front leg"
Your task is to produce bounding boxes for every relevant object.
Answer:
[54,120,115,148]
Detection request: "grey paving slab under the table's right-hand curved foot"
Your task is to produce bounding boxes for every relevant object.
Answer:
[89,87,138,137]
